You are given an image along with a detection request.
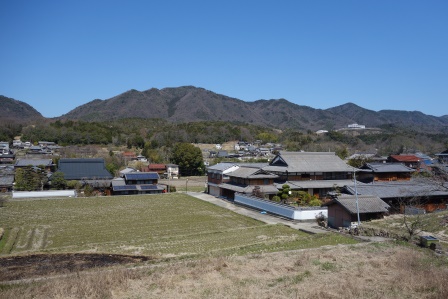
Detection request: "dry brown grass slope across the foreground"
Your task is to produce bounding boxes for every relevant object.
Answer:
[0,243,448,299]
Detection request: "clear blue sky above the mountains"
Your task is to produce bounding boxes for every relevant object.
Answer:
[0,0,448,117]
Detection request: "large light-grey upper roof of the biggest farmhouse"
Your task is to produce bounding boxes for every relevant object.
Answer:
[263,151,353,173]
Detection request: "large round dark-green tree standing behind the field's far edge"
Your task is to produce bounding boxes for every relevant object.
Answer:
[171,143,205,176]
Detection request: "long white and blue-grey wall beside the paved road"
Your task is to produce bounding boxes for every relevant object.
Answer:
[235,193,328,221]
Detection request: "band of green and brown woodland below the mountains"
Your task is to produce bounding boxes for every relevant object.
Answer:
[14,118,448,158]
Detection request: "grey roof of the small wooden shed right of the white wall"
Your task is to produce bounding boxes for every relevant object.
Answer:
[324,195,390,214]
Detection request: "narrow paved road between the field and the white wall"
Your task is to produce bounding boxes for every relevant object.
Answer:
[188,192,328,234]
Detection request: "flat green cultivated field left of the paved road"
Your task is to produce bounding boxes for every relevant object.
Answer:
[0,194,355,258]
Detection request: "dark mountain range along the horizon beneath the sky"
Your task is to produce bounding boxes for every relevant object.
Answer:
[0,86,448,132]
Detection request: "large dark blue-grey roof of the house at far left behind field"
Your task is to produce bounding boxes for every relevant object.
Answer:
[59,158,113,180]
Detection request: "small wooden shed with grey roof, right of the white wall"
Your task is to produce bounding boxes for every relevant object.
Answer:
[324,195,389,228]
